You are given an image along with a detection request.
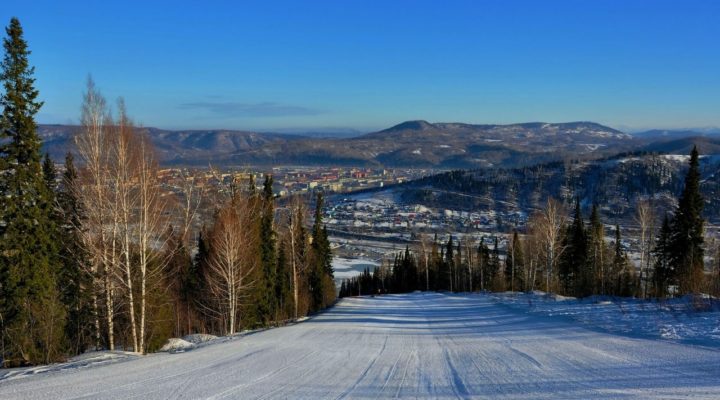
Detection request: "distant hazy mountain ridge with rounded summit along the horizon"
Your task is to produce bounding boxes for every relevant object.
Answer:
[38,120,716,169]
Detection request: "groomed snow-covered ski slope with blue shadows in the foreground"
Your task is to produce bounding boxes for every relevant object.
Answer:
[0,294,720,399]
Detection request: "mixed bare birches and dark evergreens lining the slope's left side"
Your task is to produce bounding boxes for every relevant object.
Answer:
[0,18,335,366]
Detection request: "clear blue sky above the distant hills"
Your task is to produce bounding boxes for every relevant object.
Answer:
[0,0,720,131]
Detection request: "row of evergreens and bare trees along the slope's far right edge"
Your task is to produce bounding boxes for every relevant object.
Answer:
[340,148,720,298]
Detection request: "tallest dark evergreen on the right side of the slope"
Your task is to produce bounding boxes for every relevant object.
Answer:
[670,147,705,294]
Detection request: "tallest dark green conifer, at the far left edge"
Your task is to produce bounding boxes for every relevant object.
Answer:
[0,18,65,365]
